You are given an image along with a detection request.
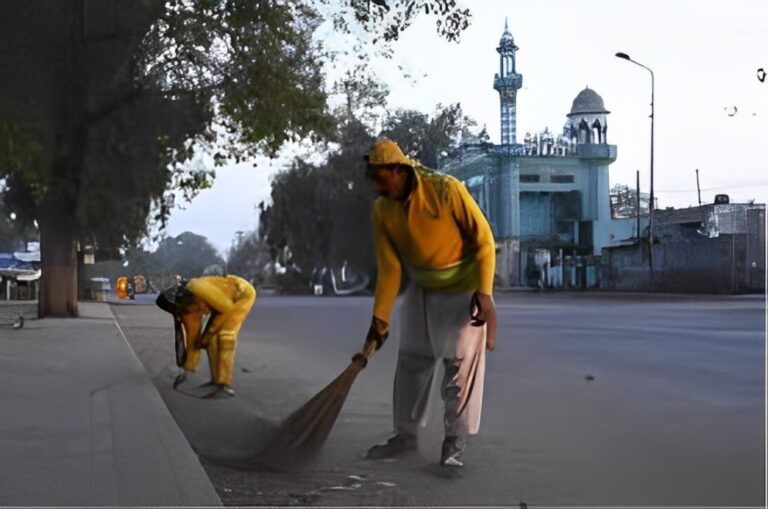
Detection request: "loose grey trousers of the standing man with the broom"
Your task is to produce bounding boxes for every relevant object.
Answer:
[393,283,486,446]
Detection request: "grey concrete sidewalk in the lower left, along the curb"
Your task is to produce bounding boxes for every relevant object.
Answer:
[0,302,221,506]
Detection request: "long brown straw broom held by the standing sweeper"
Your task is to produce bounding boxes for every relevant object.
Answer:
[255,344,375,468]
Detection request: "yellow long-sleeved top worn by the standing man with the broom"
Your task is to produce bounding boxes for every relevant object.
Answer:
[372,166,496,322]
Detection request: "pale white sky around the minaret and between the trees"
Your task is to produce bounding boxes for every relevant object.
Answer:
[166,0,768,254]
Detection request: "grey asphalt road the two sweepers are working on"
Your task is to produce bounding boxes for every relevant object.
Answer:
[113,292,765,506]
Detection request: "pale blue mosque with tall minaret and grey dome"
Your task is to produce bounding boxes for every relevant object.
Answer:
[439,19,646,287]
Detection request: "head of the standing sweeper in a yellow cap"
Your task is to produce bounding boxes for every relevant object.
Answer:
[365,138,416,200]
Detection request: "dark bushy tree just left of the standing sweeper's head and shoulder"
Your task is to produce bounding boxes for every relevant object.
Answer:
[259,66,388,292]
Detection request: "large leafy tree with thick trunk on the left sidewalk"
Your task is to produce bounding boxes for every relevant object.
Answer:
[0,0,469,316]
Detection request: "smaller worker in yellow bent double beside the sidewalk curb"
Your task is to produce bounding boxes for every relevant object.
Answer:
[158,268,256,397]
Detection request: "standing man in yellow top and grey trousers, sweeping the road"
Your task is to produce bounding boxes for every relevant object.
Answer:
[363,139,496,467]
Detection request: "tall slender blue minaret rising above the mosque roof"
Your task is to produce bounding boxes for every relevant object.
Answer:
[493,19,523,145]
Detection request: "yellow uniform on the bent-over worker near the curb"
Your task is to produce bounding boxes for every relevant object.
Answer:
[180,275,256,385]
